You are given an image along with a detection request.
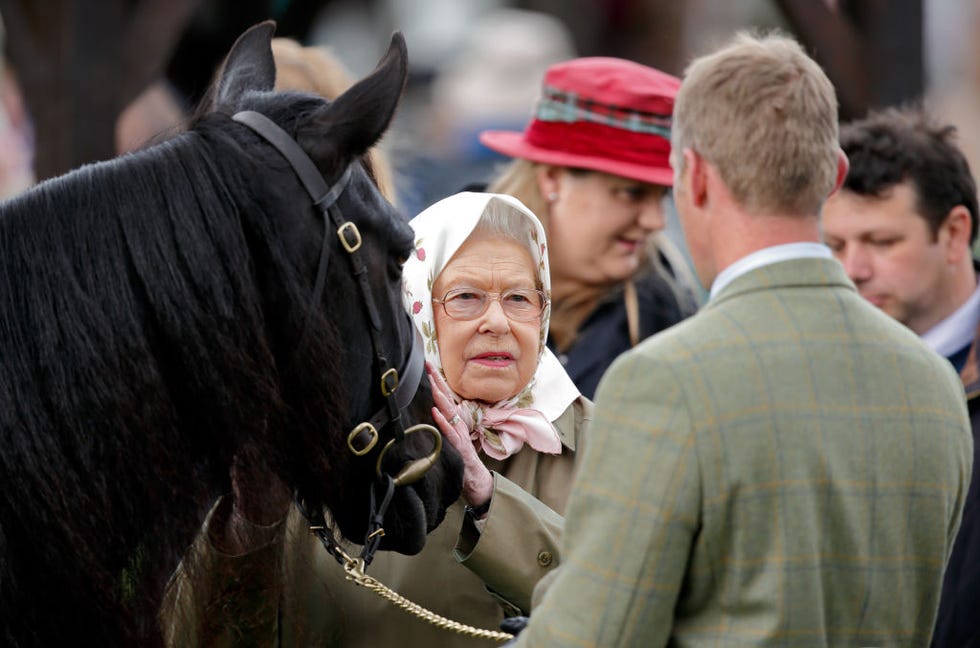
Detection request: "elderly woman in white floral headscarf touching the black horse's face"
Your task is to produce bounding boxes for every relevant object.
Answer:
[167,193,592,648]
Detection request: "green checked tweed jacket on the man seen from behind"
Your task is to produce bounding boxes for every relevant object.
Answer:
[517,259,973,648]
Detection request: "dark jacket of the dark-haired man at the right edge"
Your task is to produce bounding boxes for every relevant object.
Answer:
[932,330,980,648]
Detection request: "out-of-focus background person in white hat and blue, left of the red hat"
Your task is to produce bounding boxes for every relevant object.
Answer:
[398,8,576,213]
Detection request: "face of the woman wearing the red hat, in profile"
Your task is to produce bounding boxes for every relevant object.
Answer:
[538,167,667,297]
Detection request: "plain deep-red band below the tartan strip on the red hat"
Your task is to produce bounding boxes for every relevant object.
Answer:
[524,119,670,169]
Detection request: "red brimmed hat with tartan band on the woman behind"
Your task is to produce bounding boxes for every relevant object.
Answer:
[480,57,681,186]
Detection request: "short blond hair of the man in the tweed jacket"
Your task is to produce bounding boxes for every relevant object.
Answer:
[671,32,840,216]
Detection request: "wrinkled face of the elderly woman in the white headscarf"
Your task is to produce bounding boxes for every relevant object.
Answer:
[432,232,541,403]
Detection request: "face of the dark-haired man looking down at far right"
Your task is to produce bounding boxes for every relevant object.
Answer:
[823,183,946,334]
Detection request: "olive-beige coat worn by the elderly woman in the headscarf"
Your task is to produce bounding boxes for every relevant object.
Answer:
[162,398,592,648]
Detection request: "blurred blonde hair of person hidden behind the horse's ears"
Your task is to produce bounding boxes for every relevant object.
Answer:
[272,38,396,203]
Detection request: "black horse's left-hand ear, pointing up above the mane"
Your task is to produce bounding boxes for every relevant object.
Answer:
[211,20,276,109]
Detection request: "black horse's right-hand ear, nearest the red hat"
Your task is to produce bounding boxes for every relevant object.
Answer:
[310,32,408,157]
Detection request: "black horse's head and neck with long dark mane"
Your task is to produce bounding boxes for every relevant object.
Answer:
[0,24,461,646]
